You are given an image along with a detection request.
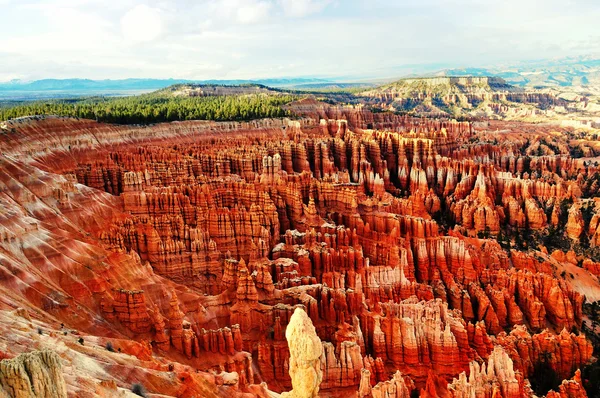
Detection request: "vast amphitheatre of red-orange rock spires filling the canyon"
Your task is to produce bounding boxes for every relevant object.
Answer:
[0,104,600,398]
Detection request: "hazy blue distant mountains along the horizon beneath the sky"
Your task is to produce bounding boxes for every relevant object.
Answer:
[0,56,600,101]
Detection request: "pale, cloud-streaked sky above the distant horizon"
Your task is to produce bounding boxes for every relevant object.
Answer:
[0,0,600,81]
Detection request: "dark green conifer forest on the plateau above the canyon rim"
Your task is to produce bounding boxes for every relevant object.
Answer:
[0,92,295,124]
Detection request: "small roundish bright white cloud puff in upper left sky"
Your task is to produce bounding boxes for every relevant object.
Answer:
[121,4,164,43]
